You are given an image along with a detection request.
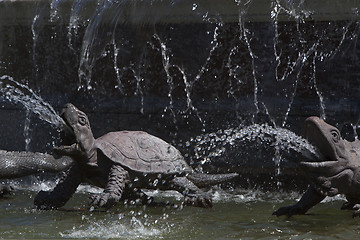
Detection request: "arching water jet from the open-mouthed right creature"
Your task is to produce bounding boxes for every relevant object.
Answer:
[190,124,321,171]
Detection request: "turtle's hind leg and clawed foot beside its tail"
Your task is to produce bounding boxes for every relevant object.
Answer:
[170,177,212,208]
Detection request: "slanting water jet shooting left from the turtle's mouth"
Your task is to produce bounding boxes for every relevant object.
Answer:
[0,75,65,129]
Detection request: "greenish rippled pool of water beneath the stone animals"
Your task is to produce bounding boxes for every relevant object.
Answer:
[0,184,360,239]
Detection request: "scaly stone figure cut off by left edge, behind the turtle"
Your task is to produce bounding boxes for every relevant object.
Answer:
[0,150,73,197]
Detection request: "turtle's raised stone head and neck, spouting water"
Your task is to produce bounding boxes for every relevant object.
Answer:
[60,103,95,157]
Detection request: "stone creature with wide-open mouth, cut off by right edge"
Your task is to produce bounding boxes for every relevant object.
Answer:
[273,117,360,217]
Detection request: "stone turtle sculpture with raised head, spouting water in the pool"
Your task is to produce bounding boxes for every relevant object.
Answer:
[34,103,238,209]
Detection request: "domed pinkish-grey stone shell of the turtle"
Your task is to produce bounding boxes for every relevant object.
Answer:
[95,131,192,174]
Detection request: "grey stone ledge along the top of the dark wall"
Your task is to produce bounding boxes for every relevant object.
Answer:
[0,0,360,26]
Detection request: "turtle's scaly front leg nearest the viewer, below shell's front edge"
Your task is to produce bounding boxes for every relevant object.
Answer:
[89,164,130,208]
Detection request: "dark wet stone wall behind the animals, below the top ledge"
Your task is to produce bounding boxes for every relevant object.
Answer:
[0,4,360,188]
